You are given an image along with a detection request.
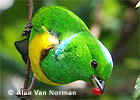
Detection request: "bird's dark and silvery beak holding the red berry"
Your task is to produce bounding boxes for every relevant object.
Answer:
[90,76,105,93]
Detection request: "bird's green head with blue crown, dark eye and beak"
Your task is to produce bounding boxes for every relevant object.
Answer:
[75,34,113,93]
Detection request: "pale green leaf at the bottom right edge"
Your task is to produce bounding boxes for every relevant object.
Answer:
[131,75,140,100]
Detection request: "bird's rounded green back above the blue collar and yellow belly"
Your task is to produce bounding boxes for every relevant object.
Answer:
[30,6,89,40]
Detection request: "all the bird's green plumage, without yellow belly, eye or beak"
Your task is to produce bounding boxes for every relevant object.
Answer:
[30,6,113,83]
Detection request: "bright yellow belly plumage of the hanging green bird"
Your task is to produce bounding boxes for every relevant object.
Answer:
[29,26,64,85]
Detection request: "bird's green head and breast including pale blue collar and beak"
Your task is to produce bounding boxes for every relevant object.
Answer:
[41,32,113,93]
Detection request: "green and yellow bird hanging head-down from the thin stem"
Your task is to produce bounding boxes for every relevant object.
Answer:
[16,6,113,93]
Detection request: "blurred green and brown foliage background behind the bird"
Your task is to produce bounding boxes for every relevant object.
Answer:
[0,0,140,100]
